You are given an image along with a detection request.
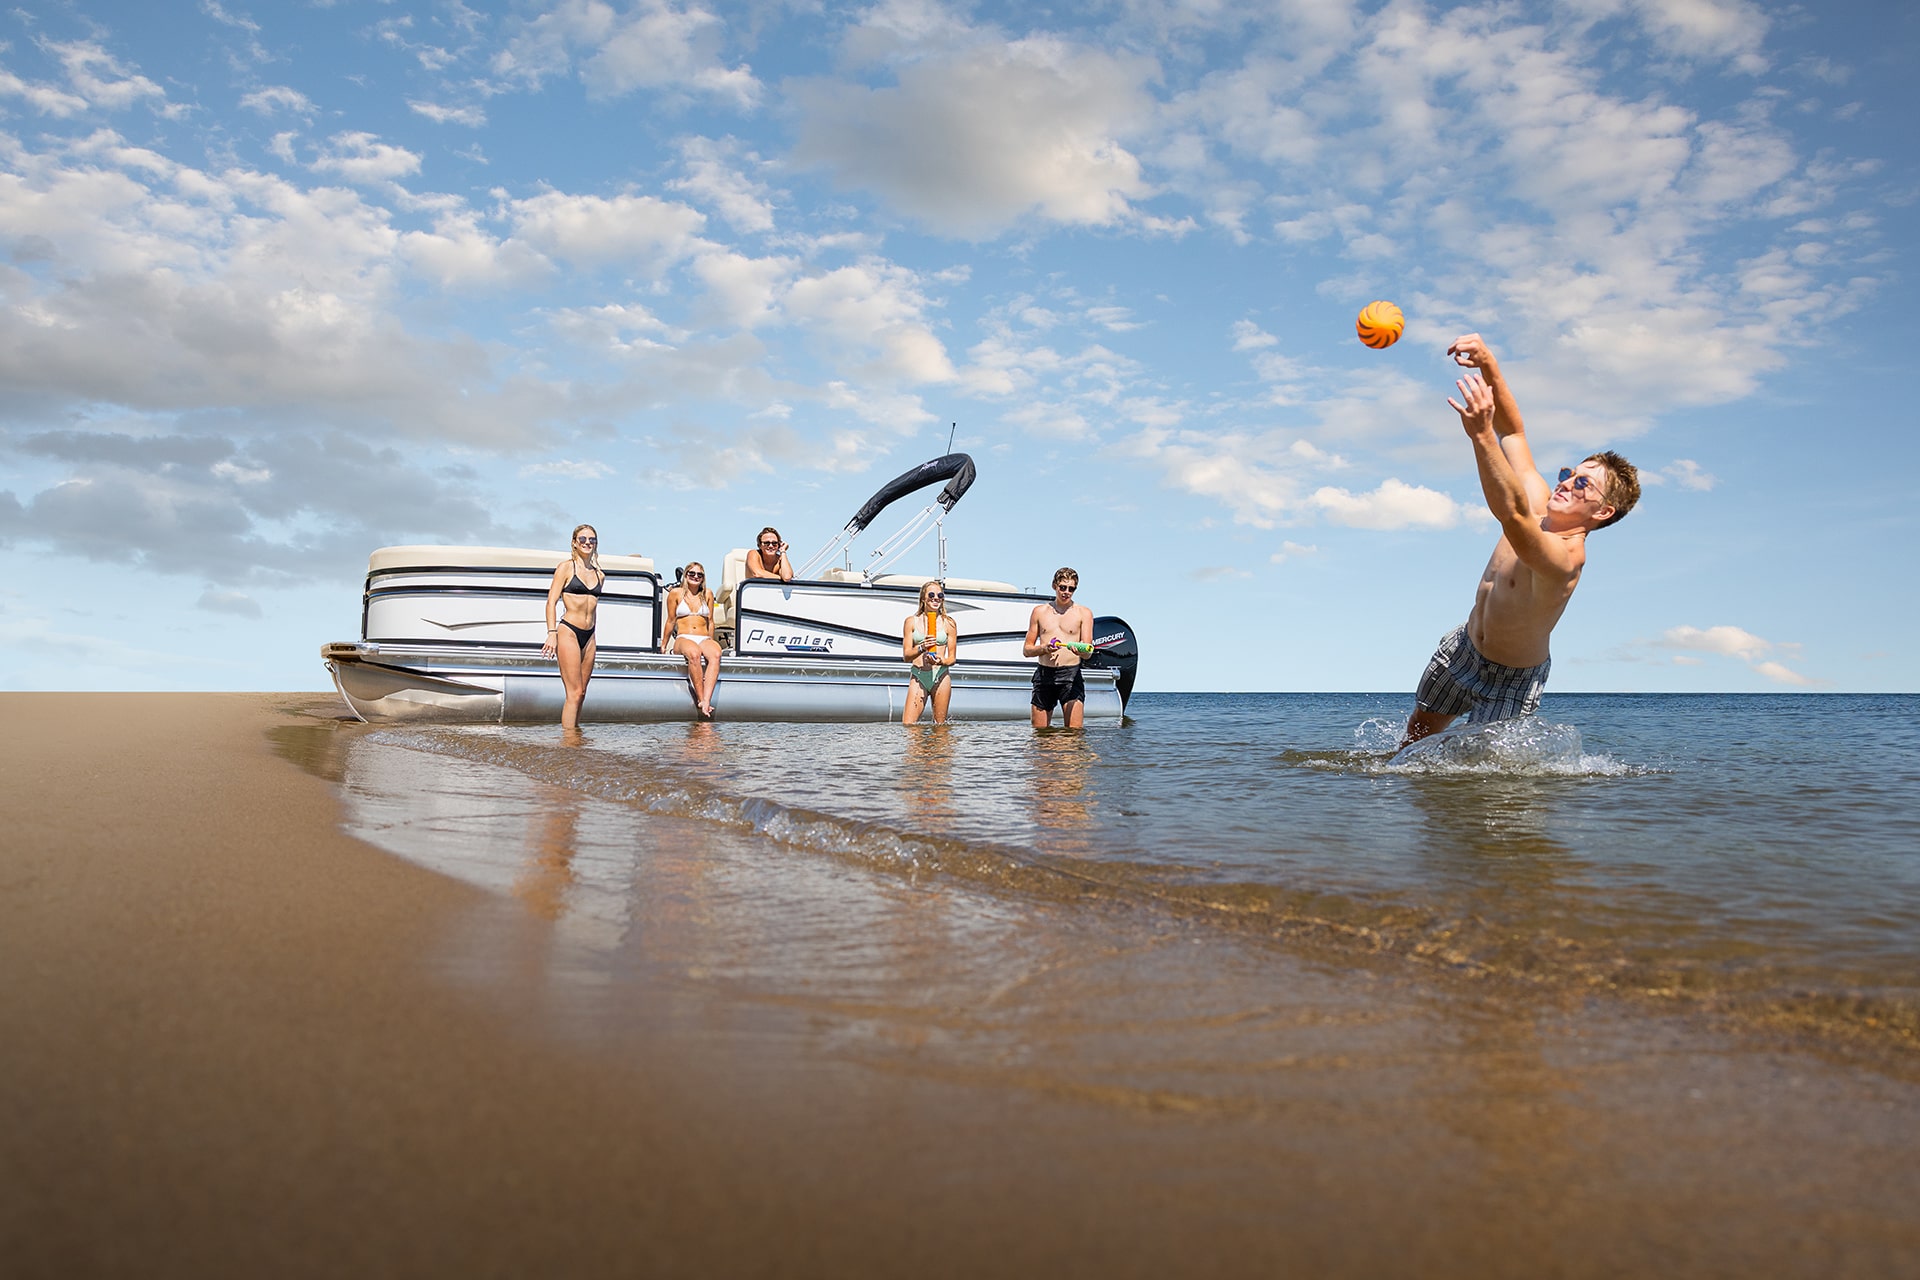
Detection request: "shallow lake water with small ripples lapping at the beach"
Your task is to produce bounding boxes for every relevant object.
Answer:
[314,695,1920,1054]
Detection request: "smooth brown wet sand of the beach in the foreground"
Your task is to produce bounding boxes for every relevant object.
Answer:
[0,695,1920,1276]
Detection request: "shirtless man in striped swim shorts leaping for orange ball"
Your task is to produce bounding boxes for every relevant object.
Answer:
[1402,334,1640,745]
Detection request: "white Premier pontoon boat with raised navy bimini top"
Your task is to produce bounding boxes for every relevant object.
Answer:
[321,453,1139,723]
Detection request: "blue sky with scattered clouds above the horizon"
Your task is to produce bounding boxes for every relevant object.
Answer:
[0,0,1920,693]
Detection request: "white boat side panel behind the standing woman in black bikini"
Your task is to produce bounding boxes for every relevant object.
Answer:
[361,564,660,654]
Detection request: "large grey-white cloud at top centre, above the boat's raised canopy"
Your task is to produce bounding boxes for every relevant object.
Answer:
[791,36,1158,240]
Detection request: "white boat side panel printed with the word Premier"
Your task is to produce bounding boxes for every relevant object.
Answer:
[733,578,1046,662]
